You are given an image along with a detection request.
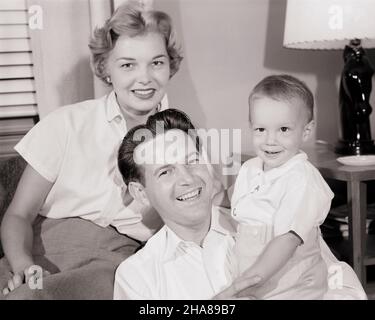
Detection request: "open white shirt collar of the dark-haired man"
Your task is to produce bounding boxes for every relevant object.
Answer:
[164,206,236,262]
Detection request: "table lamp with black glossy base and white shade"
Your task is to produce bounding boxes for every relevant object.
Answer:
[284,0,375,155]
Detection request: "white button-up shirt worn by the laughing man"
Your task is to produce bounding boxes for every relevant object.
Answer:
[114,207,237,300]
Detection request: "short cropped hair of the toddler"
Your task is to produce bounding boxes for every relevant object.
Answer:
[249,74,314,122]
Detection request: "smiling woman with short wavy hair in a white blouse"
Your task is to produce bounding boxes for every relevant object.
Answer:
[0,4,182,299]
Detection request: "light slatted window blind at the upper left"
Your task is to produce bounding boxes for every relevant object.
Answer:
[0,0,38,119]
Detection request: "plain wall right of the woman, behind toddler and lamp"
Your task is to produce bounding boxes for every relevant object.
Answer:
[154,0,375,153]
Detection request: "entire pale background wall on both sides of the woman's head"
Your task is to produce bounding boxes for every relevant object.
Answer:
[29,0,375,153]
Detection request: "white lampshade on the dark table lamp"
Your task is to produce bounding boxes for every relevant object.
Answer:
[284,0,375,49]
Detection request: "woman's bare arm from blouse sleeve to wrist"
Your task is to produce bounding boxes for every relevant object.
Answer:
[1,165,53,274]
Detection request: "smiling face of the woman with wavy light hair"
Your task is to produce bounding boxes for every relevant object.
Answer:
[106,32,170,115]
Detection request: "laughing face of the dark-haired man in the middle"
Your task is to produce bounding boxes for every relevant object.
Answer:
[135,130,213,233]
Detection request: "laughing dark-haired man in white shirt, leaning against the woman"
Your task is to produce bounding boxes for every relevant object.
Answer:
[114,109,368,299]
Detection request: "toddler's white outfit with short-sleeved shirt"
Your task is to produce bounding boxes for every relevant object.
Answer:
[232,152,333,299]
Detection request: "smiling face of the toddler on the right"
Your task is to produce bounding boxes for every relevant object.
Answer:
[250,97,313,171]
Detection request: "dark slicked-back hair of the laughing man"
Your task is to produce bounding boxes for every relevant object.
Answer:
[117,109,201,185]
